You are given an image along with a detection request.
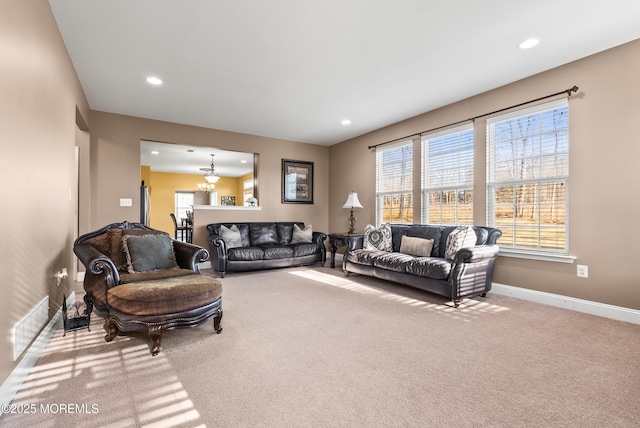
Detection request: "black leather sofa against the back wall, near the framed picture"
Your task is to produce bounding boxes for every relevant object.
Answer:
[207,222,327,277]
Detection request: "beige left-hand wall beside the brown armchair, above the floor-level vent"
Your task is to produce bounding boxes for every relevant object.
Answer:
[0,0,88,382]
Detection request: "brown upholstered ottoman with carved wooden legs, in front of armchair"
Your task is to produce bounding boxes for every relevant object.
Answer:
[105,273,222,355]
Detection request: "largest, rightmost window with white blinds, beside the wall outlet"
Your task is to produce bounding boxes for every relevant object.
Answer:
[487,99,569,254]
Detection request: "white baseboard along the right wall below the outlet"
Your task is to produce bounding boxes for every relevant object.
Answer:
[491,282,640,324]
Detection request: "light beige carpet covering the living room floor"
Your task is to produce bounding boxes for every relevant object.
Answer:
[0,267,640,428]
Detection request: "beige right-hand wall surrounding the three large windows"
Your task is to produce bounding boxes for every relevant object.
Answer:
[329,40,640,309]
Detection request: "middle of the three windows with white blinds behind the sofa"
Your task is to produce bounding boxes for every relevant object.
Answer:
[422,124,473,225]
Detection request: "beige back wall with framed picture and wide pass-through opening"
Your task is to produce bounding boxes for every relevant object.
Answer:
[91,111,329,247]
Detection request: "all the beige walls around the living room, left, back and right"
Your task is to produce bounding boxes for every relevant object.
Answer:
[0,0,640,392]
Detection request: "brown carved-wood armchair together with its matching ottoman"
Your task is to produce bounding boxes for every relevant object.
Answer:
[73,221,222,355]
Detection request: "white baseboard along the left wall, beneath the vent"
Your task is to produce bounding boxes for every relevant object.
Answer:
[0,292,76,410]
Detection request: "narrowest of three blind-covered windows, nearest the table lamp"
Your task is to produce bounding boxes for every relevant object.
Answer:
[376,141,413,224]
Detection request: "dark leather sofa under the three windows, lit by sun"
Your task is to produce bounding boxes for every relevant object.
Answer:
[343,224,502,307]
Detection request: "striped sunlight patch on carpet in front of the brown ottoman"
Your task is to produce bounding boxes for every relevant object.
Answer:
[6,326,203,428]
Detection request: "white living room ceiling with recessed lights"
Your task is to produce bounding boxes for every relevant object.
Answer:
[49,0,640,145]
